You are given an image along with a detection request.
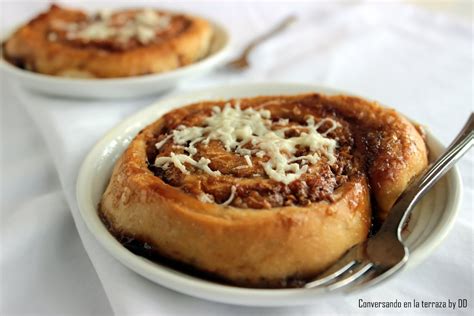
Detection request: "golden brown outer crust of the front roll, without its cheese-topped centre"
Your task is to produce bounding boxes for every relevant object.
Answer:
[100,94,426,287]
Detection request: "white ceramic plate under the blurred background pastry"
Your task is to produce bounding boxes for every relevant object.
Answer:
[0,22,229,99]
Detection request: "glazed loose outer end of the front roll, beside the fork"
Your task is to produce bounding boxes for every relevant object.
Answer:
[322,96,428,220]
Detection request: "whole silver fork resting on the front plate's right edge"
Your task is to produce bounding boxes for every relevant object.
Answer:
[305,113,474,291]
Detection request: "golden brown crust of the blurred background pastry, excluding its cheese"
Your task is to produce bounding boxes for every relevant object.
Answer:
[4,5,213,78]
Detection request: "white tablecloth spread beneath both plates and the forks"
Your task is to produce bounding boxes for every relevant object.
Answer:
[0,1,474,315]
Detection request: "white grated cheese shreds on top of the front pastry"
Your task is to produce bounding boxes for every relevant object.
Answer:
[155,103,340,184]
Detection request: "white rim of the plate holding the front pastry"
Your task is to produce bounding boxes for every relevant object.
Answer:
[76,82,462,306]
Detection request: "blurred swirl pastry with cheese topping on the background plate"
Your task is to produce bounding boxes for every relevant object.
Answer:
[4,5,213,78]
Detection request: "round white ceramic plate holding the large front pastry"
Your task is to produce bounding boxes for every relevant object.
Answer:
[77,84,461,306]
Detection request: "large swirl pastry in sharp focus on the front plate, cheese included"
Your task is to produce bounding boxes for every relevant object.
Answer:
[100,94,427,287]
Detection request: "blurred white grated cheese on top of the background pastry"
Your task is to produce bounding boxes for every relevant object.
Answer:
[55,9,171,45]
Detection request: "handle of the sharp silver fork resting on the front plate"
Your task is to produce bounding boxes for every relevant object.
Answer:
[380,113,474,240]
